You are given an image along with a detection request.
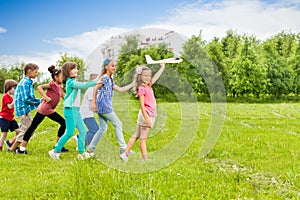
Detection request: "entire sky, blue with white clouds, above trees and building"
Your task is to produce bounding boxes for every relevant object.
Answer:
[0,0,300,72]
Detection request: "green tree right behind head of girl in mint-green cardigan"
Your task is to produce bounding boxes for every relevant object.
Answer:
[56,53,86,81]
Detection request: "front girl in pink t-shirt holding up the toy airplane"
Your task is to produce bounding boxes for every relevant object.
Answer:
[120,63,165,161]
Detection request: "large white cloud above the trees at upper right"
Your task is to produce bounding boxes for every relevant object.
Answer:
[148,0,300,40]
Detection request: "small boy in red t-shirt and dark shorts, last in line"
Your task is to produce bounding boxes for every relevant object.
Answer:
[0,80,19,151]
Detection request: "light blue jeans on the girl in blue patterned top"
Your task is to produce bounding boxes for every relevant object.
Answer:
[89,112,127,152]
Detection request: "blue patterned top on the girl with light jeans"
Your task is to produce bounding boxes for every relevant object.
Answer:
[96,75,114,114]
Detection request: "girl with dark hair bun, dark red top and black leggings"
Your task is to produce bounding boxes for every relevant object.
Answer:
[16,65,69,154]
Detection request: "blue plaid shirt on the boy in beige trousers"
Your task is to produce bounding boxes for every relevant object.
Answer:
[14,76,41,116]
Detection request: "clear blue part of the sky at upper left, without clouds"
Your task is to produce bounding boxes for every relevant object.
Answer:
[0,0,195,54]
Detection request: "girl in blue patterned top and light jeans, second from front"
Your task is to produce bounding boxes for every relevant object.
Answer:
[88,58,135,159]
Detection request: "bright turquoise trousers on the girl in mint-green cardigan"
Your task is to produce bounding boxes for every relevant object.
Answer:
[54,107,86,153]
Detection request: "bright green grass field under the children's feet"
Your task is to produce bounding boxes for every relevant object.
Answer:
[0,95,300,199]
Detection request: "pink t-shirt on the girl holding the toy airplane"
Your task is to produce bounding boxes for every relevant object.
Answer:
[138,85,156,117]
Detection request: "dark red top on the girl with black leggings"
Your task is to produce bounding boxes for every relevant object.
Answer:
[37,81,62,115]
